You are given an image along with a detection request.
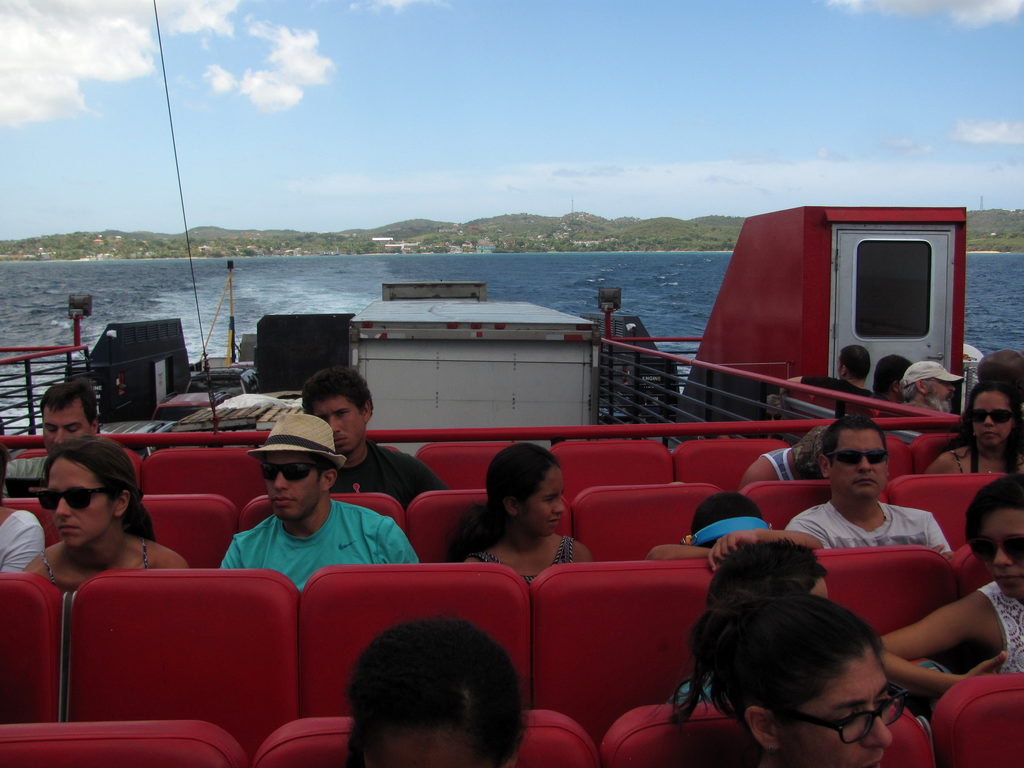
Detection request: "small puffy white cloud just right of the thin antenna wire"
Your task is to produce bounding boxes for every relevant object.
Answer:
[204,22,334,112]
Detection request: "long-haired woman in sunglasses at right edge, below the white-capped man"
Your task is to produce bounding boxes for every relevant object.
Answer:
[925,381,1024,474]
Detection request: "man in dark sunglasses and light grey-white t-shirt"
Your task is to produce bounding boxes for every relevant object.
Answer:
[785,414,950,554]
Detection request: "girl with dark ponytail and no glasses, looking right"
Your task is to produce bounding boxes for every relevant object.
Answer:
[447,442,594,582]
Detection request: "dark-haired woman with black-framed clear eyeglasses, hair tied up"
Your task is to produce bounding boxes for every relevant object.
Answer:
[677,594,906,768]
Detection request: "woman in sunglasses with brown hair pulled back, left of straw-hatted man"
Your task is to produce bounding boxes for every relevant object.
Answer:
[26,436,188,592]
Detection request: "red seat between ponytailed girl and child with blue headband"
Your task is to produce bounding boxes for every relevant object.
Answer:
[572,482,721,560]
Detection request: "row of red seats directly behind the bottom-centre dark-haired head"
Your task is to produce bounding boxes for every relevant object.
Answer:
[0,547,974,754]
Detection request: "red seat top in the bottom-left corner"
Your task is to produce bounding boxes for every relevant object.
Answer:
[0,720,247,768]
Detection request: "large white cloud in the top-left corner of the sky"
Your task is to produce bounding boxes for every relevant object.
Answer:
[0,0,240,126]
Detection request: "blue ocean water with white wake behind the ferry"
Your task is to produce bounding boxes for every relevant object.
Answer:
[0,253,1024,359]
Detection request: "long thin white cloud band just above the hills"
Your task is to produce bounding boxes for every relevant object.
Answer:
[287,158,1024,225]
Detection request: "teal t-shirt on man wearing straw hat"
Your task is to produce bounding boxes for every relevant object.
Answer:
[220,501,420,590]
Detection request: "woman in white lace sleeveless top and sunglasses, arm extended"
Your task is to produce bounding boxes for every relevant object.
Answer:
[883,474,1024,697]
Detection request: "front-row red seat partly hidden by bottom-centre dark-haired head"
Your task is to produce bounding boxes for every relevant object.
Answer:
[252,710,600,768]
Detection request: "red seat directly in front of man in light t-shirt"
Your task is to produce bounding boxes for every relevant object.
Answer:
[817,546,956,635]
